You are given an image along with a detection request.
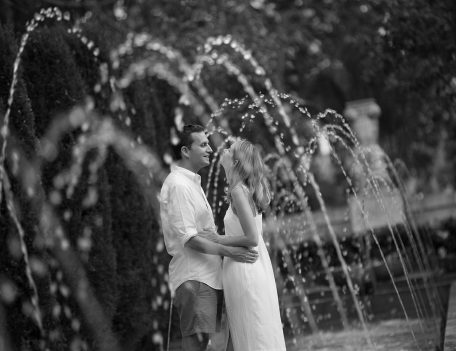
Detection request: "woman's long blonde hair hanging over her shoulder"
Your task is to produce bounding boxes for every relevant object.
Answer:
[227,139,271,213]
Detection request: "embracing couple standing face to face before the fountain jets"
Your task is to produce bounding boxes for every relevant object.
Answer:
[160,125,285,351]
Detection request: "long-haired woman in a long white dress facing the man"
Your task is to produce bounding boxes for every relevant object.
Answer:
[203,140,286,351]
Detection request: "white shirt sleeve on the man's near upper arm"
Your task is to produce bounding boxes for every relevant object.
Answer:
[167,184,198,247]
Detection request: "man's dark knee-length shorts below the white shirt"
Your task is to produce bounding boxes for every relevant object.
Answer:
[174,280,223,337]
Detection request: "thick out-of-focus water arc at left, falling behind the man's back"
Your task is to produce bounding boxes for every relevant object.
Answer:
[5,103,164,350]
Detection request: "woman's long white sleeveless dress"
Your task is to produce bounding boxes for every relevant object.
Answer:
[223,206,286,351]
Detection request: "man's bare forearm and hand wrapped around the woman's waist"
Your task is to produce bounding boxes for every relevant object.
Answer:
[185,236,258,263]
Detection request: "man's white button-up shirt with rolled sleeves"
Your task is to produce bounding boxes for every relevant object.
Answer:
[160,165,222,293]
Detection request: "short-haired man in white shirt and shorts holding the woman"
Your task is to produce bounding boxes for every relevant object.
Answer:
[160,125,258,351]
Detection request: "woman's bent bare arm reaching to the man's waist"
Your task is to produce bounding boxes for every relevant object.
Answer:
[207,186,259,247]
